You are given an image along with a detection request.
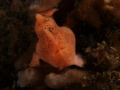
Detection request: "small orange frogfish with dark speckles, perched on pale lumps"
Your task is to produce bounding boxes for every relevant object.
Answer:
[30,9,84,69]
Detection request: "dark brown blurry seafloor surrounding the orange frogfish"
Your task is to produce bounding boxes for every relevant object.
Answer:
[0,0,120,90]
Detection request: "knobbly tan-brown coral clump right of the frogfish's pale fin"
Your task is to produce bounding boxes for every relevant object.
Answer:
[91,41,120,70]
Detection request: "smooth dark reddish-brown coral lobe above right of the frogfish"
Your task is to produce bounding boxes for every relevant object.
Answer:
[71,0,103,28]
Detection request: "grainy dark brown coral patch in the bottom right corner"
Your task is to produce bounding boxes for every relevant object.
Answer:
[88,71,120,90]
